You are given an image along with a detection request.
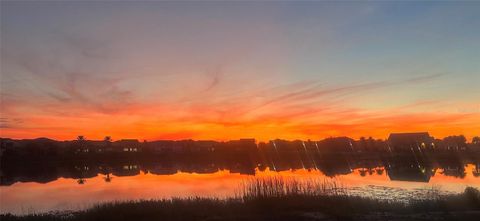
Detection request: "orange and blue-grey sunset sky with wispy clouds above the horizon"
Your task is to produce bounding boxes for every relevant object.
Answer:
[0,1,480,140]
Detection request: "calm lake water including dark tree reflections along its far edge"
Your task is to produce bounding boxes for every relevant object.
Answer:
[0,162,480,214]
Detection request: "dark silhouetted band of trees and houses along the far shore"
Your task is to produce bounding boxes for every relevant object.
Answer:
[0,133,480,160]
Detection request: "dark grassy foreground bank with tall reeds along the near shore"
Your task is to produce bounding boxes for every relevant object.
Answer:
[0,178,480,221]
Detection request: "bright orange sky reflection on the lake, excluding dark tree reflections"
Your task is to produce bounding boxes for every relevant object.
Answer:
[0,164,480,213]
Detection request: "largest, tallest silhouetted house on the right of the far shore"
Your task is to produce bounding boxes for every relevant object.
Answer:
[387,132,435,152]
